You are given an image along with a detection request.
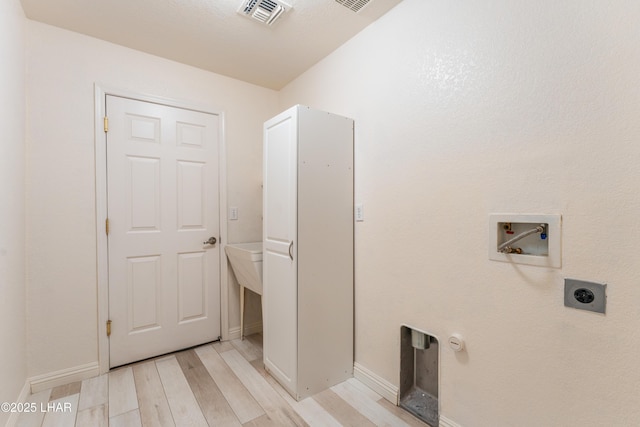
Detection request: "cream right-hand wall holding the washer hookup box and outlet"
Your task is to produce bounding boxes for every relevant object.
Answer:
[280,0,640,427]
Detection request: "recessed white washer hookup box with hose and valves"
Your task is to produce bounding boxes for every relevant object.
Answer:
[488,214,562,268]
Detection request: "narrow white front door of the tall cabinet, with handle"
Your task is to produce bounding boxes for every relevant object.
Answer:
[262,107,298,394]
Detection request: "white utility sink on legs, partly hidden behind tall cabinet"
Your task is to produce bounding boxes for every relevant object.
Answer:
[225,242,262,338]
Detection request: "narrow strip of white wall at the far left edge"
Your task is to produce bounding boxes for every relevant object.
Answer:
[0,0,27,425]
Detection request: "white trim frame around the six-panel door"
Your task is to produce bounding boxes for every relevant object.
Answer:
[94,83,229,374]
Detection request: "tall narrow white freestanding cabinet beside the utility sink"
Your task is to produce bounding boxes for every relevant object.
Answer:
[263,105,353,400]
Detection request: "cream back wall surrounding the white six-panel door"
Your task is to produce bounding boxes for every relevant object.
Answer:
[27,21,277,376]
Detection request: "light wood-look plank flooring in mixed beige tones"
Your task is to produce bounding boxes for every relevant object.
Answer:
[17,334,426,427]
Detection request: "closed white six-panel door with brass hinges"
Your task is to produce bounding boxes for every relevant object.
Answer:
[106,96,220,367]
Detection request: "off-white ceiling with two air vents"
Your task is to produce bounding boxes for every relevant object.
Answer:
[21,0,401,89]
